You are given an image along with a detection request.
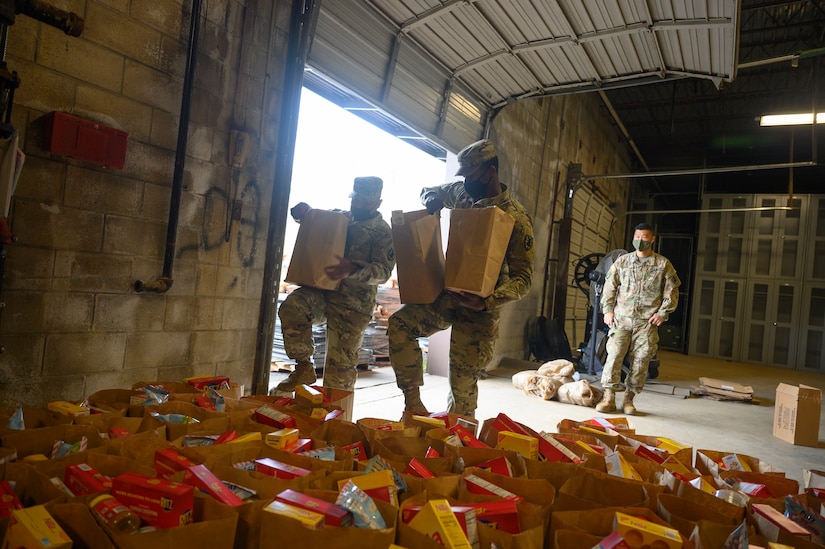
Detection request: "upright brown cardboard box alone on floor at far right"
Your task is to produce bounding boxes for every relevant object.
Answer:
[773,383,822,447]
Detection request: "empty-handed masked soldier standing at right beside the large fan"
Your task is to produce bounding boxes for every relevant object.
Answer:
[596,223,681,415]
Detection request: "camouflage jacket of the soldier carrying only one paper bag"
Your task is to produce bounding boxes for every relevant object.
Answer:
[328,212,395,313]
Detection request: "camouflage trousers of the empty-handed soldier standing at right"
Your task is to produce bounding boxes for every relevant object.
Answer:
[602,321,659,393]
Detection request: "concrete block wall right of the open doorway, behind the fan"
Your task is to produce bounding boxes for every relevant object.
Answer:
[491,93,630,367]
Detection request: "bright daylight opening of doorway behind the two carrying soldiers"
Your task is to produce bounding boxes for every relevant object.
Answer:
[270,88,455,388]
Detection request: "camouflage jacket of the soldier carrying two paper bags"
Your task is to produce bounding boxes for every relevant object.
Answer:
[421,181,533,311]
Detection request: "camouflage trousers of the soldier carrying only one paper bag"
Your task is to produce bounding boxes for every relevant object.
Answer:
[278,287,371,391]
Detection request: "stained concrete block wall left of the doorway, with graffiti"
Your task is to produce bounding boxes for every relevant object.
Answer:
[0,0,290,406]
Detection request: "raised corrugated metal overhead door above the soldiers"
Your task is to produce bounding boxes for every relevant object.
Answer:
[307,0,739,155]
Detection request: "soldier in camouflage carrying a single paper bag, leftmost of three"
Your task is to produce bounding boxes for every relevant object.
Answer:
[275,177,395,392]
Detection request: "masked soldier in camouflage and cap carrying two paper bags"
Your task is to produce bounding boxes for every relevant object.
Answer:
[388,140,533,417]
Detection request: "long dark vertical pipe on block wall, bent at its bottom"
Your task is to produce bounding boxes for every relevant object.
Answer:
[134,0,201,293]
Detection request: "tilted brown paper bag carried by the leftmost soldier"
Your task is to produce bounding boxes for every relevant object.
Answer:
[285,210,349,290]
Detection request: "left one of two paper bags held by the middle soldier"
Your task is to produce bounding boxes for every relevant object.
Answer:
[392,210,444,304]
